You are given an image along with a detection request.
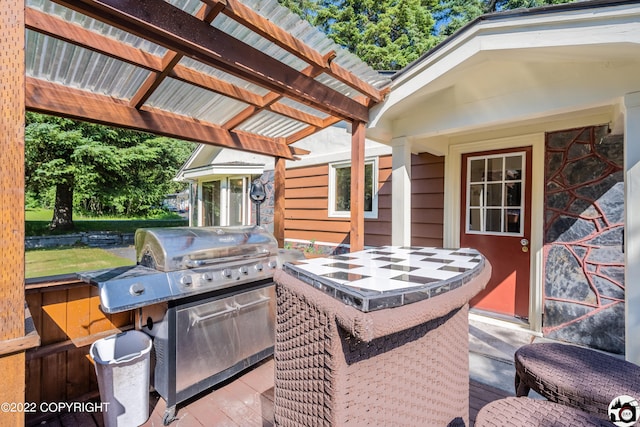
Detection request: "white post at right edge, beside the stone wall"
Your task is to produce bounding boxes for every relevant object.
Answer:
[624,92,640,364]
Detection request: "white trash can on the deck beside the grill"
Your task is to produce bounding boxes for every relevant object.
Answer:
[89,331,151,427]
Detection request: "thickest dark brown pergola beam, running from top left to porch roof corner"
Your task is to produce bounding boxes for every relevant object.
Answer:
[55,0,368,121]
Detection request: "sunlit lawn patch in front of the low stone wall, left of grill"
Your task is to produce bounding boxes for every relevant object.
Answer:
[25,247,135,278]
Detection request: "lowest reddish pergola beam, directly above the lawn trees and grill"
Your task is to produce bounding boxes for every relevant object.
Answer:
[26,78,307,160]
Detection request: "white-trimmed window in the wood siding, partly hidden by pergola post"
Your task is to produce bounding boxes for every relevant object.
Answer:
[329,158,378,218]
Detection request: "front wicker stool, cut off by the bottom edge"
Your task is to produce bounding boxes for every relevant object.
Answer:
[475,397,614,427]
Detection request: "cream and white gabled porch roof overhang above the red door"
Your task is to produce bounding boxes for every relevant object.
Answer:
[367,0,640,155]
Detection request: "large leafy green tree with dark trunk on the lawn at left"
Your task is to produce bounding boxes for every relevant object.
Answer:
[25,113,194,229]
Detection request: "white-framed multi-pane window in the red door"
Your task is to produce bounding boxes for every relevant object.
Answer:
[466,153,525,235]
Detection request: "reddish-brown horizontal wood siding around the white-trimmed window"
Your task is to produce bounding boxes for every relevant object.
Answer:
[285,154,444,246]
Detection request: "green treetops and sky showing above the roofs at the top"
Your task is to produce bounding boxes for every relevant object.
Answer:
[279,0,572,70]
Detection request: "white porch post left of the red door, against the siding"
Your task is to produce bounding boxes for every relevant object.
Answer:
[391,138,411,246]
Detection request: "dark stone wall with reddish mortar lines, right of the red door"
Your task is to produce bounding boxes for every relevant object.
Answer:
[543,126,625,353]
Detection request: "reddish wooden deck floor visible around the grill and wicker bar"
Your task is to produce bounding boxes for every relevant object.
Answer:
[31,359,513,427]
